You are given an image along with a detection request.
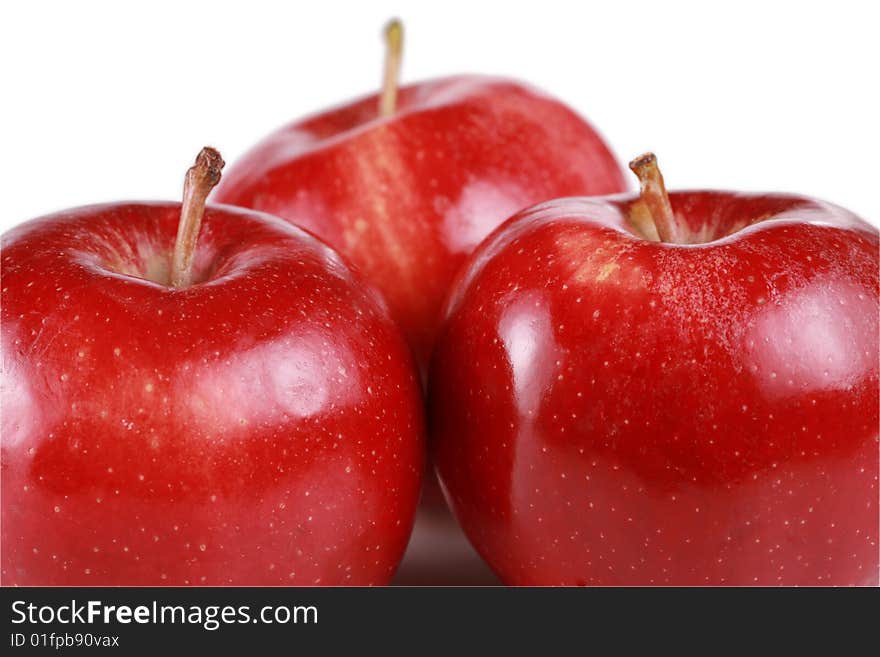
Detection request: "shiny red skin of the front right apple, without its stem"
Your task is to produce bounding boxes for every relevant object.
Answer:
[429,192,878,585]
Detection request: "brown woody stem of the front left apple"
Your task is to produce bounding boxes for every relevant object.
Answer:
[171,146,225,287]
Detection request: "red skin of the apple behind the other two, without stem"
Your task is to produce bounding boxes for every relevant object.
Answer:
[213,76,627,372]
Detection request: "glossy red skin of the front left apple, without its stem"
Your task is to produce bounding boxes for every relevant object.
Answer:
[2,203,425,585]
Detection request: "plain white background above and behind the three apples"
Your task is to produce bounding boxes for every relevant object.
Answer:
[0,0,880,230]
